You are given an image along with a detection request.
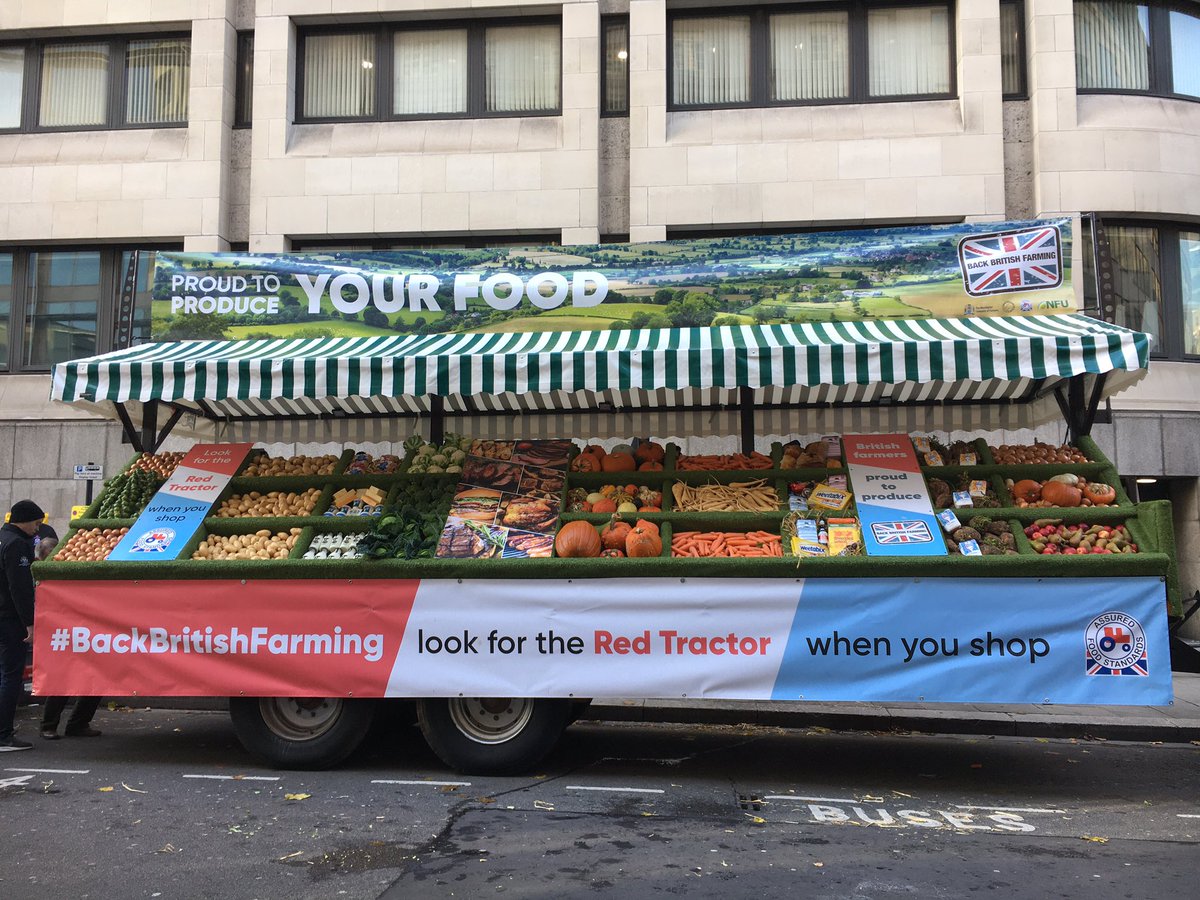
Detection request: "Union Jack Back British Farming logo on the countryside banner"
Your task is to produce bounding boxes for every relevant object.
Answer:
[959,226,1062,296]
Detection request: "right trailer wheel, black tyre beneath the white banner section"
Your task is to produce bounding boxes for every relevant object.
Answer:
[416,697,571,775]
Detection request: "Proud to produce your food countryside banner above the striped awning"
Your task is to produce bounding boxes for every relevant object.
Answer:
[151,217,1080,341]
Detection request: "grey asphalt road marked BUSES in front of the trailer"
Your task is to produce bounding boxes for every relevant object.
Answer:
[0,709,1200,900]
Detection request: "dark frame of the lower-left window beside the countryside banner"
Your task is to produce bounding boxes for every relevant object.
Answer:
[0,242,182,377]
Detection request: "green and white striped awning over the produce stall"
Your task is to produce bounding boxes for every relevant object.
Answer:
[52,314,1150,440]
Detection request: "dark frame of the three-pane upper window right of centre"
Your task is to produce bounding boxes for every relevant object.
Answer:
[666,0,959,113]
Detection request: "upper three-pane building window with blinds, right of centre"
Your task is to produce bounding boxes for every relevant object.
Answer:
[670,0,954,109]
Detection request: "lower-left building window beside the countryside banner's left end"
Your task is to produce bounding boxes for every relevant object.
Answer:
[0,246,175,372]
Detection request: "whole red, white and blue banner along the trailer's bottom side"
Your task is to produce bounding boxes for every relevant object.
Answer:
[34,578,1172,706]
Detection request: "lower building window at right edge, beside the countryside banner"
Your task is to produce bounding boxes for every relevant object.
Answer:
[1099,222,1200,359]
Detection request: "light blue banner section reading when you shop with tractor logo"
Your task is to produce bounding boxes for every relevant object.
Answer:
[772,577,1172,706]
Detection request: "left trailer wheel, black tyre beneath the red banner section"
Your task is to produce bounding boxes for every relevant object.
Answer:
[229,697,374,769]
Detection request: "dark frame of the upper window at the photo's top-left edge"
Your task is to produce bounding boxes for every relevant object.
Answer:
[0,31,192,134]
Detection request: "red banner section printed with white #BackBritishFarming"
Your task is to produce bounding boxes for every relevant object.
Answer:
[34,580,420,697]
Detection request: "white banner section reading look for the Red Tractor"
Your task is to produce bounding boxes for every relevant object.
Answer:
[386,578,804,700]
